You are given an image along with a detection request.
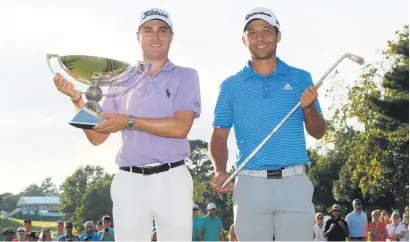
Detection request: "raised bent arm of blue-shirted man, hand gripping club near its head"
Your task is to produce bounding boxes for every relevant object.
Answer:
[300,73,326,139]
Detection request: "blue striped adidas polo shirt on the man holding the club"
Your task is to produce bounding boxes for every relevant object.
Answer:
[213,58,322,170]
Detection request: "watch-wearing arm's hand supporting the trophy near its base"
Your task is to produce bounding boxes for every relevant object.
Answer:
[94,113,128,133]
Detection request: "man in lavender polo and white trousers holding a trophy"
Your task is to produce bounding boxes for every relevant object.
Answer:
[54,6,201,241]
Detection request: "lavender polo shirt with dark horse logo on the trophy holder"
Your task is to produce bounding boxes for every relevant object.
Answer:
[102,60,201,166]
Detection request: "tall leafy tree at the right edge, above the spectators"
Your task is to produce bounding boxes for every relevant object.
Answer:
[325,26,409,208]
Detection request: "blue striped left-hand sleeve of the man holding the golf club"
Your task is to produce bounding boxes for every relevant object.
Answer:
[213,80,233,129]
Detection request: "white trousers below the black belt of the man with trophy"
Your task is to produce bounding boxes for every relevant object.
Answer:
[111,165,193,241]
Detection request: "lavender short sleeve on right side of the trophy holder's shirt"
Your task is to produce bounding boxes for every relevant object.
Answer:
[174,69,201,118]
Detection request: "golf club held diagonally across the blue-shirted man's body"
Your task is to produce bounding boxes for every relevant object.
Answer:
[221,53,364,188]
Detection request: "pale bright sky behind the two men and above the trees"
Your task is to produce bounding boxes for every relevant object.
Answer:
[0,0,409,194]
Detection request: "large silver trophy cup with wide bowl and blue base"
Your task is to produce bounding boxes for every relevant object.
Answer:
[46,54,151,129]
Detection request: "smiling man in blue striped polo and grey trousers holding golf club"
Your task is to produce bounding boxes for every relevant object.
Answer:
[210,8,326,241]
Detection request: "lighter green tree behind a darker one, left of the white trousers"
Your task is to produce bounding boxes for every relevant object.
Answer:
[59,165,109,217]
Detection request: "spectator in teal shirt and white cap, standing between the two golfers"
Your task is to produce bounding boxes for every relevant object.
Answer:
[198,203,225,241]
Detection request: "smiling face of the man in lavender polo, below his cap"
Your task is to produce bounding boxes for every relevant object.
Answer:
[138,20,173,60]
